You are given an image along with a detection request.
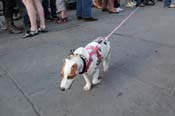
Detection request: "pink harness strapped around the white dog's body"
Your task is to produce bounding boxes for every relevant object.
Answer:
[85,45,101,72]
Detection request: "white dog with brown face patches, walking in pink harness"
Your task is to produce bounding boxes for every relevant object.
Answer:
[60,37,111,91]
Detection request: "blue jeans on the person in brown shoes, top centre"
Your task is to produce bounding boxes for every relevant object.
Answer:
[76,0,92,18]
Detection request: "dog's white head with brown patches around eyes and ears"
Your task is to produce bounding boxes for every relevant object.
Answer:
[60,59,78,91]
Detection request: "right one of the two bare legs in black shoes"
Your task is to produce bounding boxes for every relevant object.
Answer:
[34,0,46,29]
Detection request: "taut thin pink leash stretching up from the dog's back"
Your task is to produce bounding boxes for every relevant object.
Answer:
[104,7,139,41]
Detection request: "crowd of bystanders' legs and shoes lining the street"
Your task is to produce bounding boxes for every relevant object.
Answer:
[2,0,175,38]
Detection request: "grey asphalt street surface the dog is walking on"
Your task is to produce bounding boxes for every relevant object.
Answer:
[0,2,175,116]
